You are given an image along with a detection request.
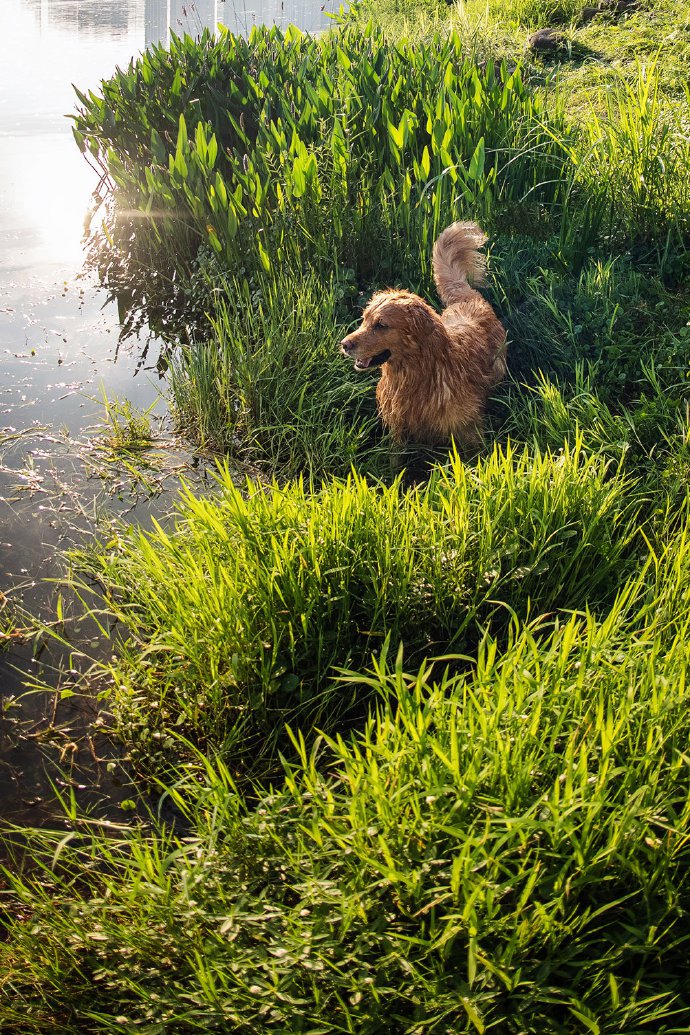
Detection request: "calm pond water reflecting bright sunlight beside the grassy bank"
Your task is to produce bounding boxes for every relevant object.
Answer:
[0,0,337,822]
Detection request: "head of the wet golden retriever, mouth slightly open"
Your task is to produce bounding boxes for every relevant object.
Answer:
[340,291,438,371]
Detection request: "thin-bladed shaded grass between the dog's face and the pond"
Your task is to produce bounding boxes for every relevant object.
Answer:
[170,267,388,478]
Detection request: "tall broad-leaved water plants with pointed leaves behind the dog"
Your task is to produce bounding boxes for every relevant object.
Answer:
[74,26,563,335]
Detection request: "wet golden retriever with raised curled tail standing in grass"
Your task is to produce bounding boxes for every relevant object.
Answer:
[340,223,506,448]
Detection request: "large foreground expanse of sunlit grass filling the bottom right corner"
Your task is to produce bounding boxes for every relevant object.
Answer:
[0,524,690,1035]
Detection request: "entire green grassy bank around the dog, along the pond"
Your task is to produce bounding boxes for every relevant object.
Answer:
[0,0,690,1035]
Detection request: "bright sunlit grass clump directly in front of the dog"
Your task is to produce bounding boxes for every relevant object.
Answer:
[72,442,640,774]
